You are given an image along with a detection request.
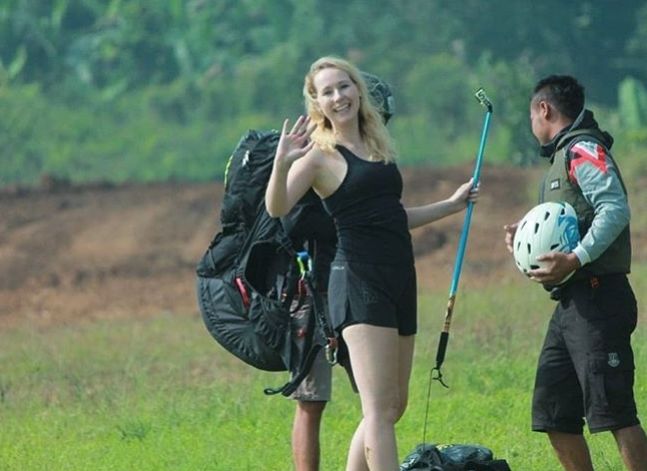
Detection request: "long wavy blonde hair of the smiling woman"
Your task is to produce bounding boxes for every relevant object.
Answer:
[303,56,396,163]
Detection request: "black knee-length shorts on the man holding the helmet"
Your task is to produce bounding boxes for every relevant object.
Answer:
[532,275,640,434]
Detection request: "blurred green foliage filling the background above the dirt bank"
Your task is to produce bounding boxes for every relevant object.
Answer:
[0,0,647,185]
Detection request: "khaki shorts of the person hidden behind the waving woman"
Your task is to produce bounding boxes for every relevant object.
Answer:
[290,303,332,401]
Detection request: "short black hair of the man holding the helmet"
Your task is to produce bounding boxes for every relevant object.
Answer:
[533,75,584,120]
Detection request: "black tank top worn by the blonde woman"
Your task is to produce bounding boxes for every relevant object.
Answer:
[323,145,413,264]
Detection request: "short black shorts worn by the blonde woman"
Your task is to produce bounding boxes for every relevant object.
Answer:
[328,260,417,335]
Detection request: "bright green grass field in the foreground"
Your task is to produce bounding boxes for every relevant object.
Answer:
[0,265,647,471]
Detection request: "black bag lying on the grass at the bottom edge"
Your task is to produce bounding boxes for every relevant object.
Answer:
[400,443,511,471]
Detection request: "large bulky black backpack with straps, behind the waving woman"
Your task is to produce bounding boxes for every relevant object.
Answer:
[196,130,335,396]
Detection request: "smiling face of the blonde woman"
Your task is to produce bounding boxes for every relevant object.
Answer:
[312,67,360,126]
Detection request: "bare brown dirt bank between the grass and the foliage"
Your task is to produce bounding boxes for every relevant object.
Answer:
[0,167,644,327]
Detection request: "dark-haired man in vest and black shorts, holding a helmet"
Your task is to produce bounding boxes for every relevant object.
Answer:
[505,75,647,471]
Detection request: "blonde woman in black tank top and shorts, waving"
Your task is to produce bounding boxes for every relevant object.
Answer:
[265,57,478,471]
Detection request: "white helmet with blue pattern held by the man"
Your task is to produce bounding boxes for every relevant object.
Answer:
[513,201,580,284]
